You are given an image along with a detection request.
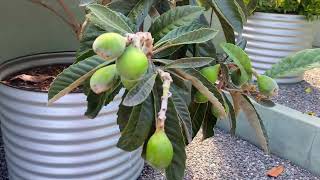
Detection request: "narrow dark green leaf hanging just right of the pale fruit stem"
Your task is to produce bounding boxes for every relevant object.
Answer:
[170,84,193,143]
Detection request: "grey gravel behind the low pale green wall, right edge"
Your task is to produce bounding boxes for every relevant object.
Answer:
[274,68,320,117]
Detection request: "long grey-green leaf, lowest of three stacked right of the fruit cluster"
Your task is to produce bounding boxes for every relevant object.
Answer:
[155,28,218,52]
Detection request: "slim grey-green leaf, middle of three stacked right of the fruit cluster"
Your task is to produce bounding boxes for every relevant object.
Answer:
[154,23,204,48]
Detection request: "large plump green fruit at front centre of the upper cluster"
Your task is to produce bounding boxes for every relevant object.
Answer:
[116,45,148,80]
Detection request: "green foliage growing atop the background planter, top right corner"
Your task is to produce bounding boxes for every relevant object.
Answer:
[256,0,320,20]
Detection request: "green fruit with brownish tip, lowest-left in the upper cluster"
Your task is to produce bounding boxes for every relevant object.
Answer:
[90,64,119,94]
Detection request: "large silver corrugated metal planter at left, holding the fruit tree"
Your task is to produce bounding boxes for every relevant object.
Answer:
[0,53,144,180]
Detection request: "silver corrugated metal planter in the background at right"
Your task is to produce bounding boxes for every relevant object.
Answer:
[243,12,313,83]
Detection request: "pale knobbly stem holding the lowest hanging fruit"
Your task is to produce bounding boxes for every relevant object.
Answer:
[156,69,173,130]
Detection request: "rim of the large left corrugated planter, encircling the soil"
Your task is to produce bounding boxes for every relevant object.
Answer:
[0,51,82,95]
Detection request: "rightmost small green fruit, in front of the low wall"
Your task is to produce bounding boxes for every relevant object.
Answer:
[257,75,279,97]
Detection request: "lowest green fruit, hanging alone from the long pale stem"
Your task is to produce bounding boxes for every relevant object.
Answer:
[146,130,173,169]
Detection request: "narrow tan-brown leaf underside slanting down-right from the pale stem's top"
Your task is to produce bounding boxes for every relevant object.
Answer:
[175,69,227,119]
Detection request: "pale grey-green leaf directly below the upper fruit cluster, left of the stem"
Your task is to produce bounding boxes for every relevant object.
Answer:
[122,74,157,106]
